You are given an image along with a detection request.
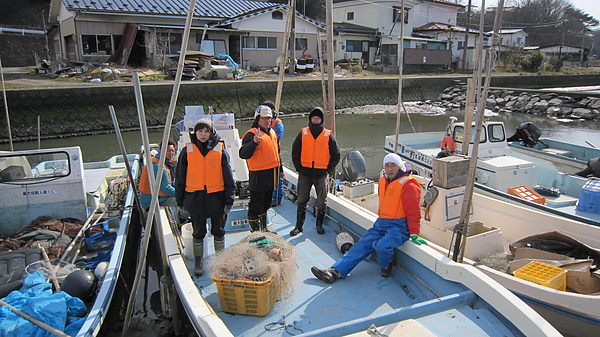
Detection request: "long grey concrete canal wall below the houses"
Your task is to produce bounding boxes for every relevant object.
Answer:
[0,75,600,142]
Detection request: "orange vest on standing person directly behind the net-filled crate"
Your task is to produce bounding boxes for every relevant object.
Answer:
[185,142,225,193]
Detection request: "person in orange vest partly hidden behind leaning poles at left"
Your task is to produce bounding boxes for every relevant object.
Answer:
[138,139,177,209]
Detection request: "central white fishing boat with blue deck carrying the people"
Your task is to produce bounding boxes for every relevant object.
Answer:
[151,108,558,336]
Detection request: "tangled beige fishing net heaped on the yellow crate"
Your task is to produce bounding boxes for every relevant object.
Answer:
[208,232,298,297]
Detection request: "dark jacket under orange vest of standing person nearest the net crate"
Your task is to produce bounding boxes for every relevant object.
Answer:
[175,133,235,218]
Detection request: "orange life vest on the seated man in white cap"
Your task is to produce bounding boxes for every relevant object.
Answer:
[377,175,419,219]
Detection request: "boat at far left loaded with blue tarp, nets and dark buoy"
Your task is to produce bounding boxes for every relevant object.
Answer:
[0,147,139,336]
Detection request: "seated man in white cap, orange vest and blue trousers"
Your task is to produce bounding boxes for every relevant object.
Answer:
[311,153,427,283]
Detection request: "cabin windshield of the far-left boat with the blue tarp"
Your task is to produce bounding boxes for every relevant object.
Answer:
[0,152,71,183]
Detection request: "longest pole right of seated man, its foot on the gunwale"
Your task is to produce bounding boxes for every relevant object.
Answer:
[452,0,504,262]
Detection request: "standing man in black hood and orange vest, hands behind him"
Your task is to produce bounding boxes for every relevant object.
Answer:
[290,107,340,236]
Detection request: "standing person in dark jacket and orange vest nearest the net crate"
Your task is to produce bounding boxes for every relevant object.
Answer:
[175,118,235,276]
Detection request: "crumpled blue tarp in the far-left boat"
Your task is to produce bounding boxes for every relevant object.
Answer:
[0,271,87,337]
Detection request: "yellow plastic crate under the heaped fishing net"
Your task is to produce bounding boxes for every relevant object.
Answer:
[212,275,280,316]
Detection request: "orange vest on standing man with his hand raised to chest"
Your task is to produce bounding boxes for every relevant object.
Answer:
[242,128,281,171]
